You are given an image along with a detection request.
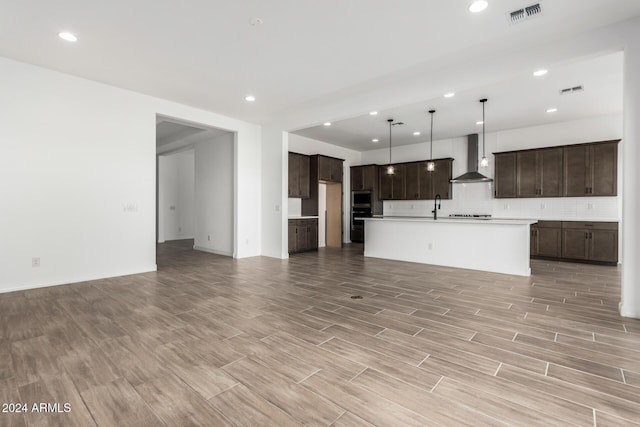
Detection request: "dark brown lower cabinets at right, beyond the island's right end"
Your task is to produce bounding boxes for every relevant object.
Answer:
[531,221,618,265]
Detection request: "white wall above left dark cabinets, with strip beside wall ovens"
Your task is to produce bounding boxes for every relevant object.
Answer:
[288,134,361,243]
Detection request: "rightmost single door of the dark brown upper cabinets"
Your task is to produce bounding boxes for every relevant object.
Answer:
[587,143,618,196]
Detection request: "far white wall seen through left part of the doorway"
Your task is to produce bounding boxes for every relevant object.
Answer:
[158,150,196,243]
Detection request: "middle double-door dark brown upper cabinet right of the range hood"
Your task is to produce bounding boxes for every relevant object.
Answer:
[516,147,563,197]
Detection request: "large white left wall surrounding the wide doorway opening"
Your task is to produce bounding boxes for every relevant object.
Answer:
[0,58,262,291]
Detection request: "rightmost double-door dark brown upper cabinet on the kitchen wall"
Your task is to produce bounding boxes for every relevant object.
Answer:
[563,140,619,197]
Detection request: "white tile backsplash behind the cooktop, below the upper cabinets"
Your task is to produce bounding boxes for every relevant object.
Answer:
[384,183,620,221]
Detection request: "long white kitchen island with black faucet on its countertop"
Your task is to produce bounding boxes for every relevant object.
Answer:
[363,217,537,276]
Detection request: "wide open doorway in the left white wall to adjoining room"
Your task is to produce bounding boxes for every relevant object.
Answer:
[156,116,235,259]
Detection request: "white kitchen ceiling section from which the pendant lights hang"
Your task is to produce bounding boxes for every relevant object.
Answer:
[293,52,623,151]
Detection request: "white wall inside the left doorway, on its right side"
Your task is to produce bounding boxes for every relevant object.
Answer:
[194,134,234,256]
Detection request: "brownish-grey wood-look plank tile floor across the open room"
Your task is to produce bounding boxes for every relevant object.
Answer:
[0,241,640,426]
